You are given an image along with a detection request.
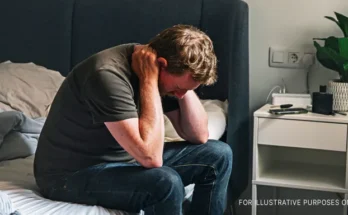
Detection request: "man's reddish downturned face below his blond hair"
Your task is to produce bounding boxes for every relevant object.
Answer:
[158,67,200,99]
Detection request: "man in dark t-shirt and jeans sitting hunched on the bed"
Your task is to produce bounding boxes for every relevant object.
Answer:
[34,25,232,215]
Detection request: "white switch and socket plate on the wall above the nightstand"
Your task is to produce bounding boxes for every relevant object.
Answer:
[269,47,316,69]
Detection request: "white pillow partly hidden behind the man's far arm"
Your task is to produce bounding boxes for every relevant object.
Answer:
[164,100,228,142]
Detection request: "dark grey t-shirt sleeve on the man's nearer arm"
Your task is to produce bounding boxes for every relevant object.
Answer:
[84,70,138,123]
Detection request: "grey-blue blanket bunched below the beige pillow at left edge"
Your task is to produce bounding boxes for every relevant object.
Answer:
[0,111,46,161]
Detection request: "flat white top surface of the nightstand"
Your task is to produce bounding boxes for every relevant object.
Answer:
[254,104,348,124]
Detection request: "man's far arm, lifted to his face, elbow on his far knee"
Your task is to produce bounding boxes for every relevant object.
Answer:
[165,90,209,144]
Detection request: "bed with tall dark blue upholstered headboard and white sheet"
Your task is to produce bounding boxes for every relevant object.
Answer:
[0,0,251,215]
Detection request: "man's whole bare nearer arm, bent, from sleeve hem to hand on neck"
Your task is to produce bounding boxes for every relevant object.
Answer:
[105,46,164,168]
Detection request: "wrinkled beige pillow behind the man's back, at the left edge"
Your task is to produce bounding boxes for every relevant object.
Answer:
[0,61,64,118]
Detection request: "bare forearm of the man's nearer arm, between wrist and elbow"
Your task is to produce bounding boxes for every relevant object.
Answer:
[139,81,164,159]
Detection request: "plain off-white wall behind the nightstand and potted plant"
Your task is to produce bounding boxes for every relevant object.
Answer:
[237,0,348,215]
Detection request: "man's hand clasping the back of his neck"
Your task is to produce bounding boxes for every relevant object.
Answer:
[132,45,159,84]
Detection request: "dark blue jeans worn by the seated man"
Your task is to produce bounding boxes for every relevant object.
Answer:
[37,140,232,215]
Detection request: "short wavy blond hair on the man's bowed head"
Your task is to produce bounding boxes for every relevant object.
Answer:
[149,25,217,85]
